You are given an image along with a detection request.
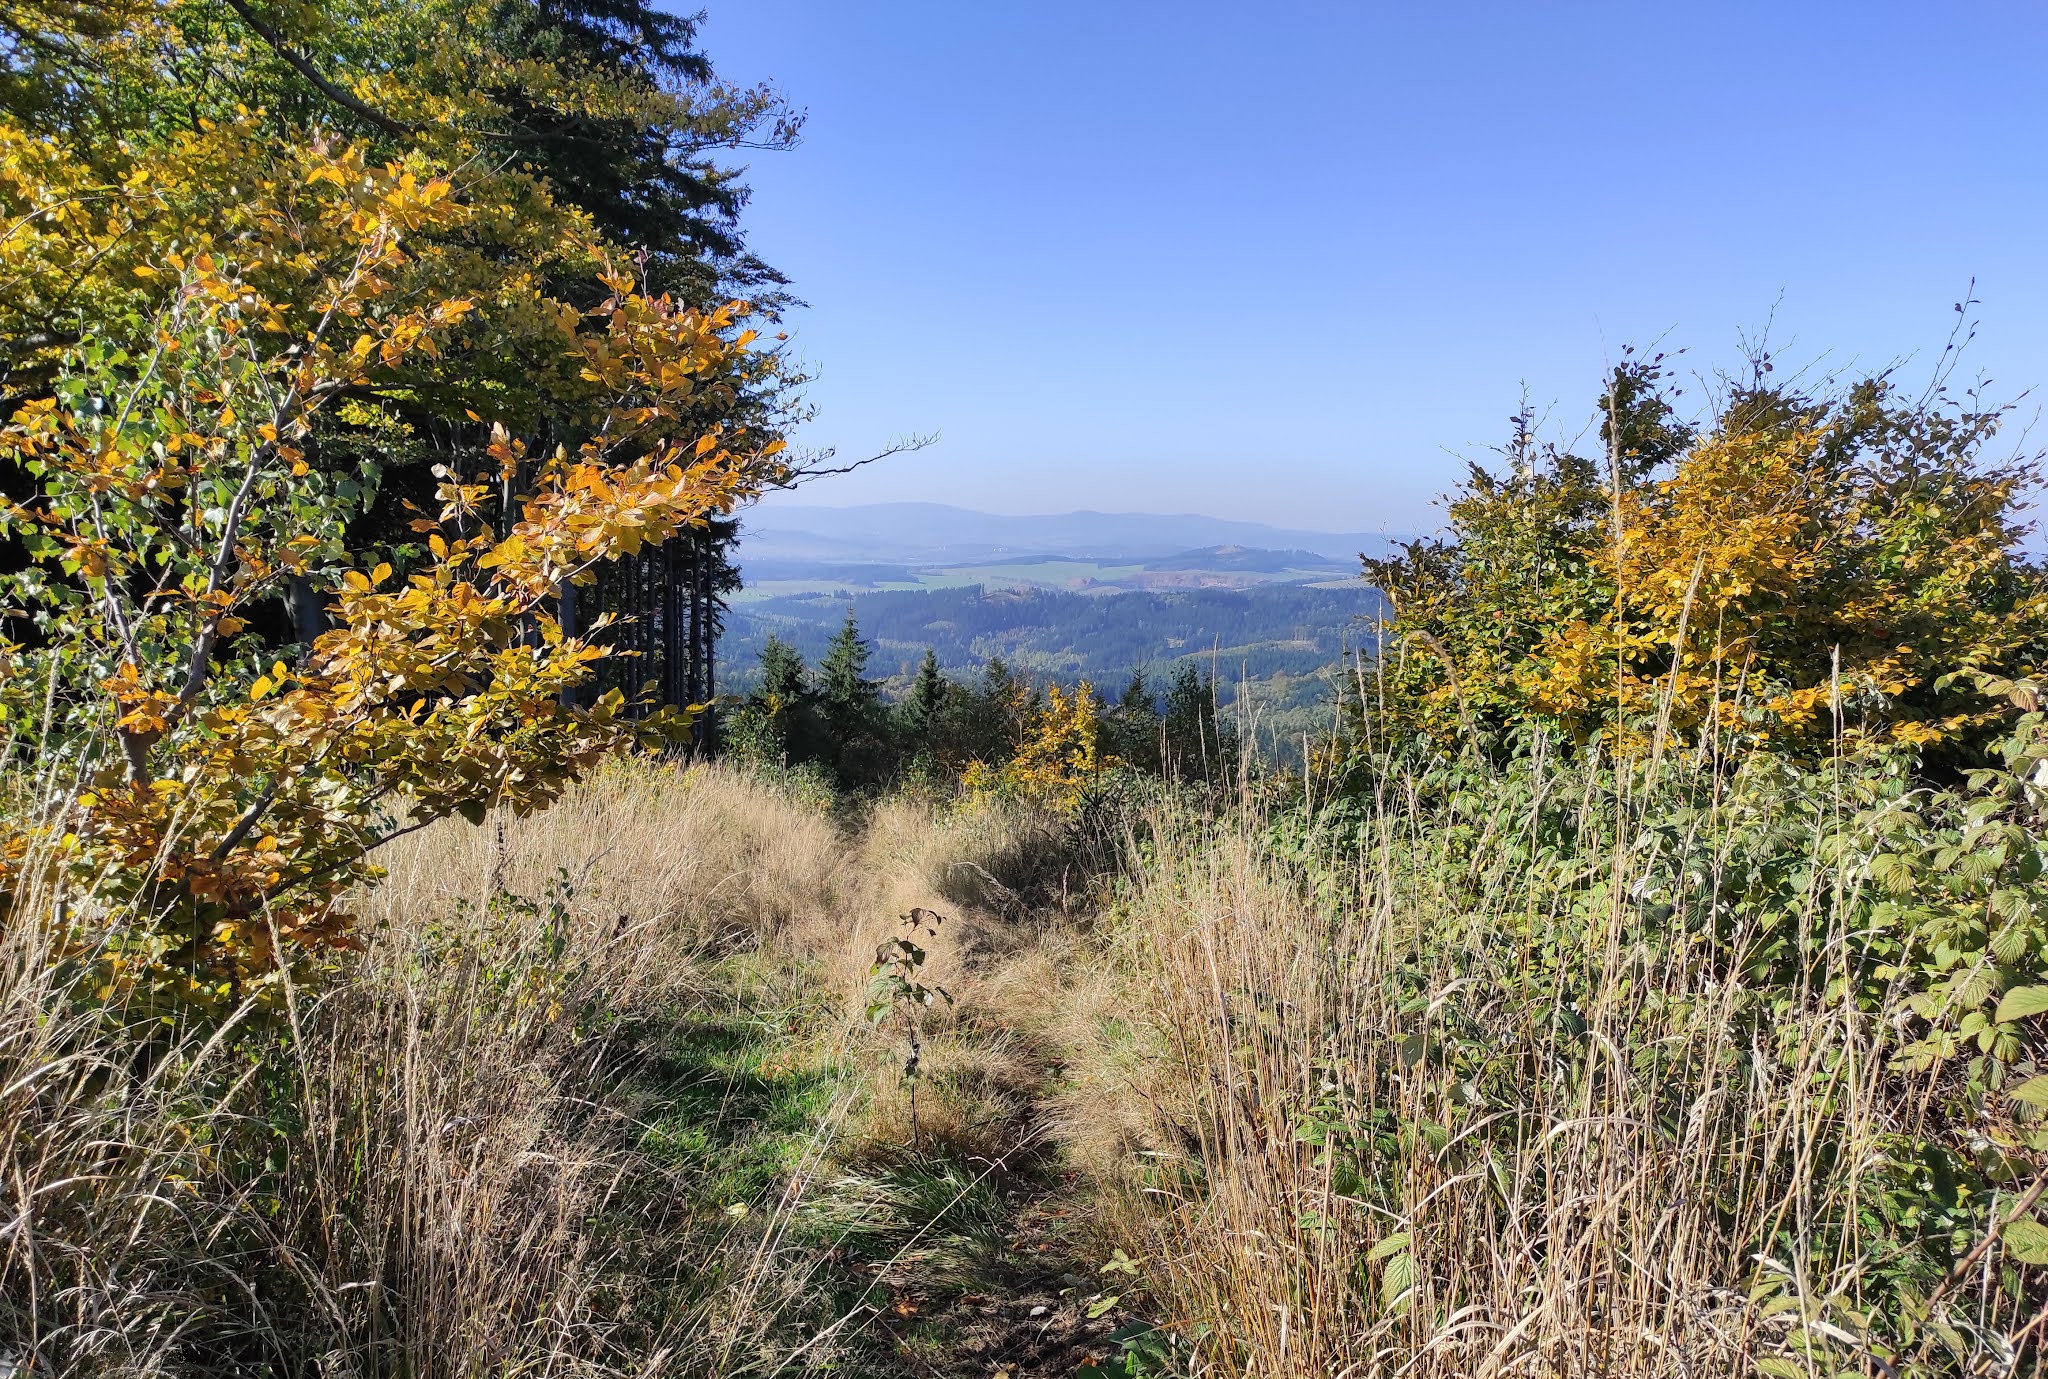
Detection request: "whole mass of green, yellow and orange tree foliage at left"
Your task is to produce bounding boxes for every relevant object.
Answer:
[0,2,788,1008]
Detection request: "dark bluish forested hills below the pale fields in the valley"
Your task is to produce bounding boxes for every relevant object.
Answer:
[721,582,1380,691]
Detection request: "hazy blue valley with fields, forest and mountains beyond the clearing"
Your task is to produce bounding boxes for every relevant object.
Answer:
[719,502,1391,729]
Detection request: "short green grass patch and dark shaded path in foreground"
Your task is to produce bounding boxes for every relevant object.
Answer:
[625,955,1128,1379]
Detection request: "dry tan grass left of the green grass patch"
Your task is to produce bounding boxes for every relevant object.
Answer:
[0,764,864,1375]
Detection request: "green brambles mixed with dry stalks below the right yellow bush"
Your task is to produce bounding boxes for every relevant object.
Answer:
[1065,704,2048,1375]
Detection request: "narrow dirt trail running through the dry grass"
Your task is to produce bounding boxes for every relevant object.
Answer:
[806,811,1130,1379]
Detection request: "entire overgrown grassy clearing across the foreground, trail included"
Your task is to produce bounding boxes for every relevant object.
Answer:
[12,704,2048,1375]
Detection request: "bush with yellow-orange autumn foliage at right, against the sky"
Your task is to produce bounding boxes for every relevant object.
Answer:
[1366,350,2048,754]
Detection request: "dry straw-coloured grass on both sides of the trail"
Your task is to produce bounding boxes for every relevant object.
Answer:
[32,741,1990,1379]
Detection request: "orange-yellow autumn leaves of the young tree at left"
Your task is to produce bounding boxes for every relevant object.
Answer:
[0,112,776,1000]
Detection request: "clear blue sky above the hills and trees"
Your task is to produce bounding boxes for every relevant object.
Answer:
[702,0,2048,533]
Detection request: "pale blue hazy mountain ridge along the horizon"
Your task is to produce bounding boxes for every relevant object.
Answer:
[739,502,1393,566]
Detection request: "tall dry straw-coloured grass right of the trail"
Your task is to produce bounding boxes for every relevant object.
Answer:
[1059,770,2040,1379]
